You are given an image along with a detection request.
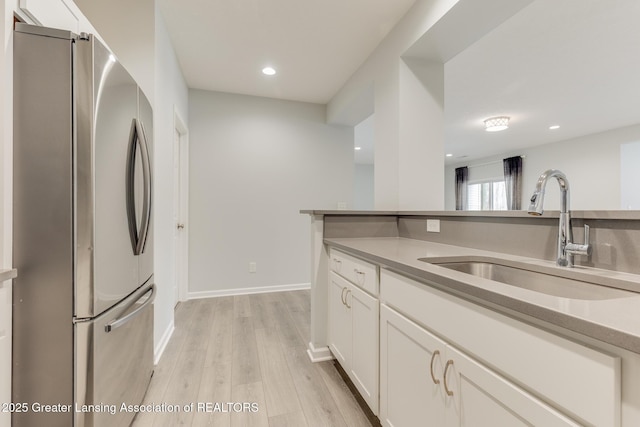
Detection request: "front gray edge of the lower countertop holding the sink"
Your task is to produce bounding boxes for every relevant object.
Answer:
[325,239,640,354]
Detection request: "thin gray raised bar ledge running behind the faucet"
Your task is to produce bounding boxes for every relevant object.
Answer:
[300,209,640,220]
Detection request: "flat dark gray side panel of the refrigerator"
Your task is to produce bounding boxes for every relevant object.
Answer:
[13,27,74,427]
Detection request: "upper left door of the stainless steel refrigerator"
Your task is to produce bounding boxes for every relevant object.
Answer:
[74,37,141,318]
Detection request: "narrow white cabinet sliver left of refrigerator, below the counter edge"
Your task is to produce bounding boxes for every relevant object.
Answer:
[0,280,11,427]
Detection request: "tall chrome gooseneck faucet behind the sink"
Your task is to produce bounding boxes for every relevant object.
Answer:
[529,169,591,267]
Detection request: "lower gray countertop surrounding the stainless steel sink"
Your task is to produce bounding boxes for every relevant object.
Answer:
[324,237,640,353]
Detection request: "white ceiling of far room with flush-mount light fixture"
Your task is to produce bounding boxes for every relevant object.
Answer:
[445,0,640,163]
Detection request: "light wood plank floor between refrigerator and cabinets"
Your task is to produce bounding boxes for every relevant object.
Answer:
[133,291,371,427]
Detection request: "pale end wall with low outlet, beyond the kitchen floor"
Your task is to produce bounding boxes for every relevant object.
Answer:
[189,90,353,297]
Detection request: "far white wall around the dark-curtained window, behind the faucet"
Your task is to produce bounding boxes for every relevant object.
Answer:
[445,125,640,210]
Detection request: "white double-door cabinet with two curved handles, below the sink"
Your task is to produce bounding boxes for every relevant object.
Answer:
[380,305,580,427]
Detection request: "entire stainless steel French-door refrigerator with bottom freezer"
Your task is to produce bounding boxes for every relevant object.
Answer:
[12,24,155,427]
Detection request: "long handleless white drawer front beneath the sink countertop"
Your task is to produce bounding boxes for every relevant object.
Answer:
[380,270,621,427]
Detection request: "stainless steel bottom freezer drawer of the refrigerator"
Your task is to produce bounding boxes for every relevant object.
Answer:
[74,285,155,427]
